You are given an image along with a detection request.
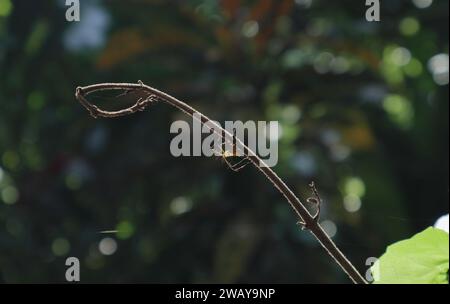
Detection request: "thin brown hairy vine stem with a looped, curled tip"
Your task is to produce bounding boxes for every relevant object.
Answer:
[75,81,367,284]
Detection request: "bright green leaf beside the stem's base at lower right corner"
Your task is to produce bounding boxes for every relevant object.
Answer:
[371,227,449,284]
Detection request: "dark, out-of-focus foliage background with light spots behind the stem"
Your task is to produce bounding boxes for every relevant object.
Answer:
[0,0,449,283]
